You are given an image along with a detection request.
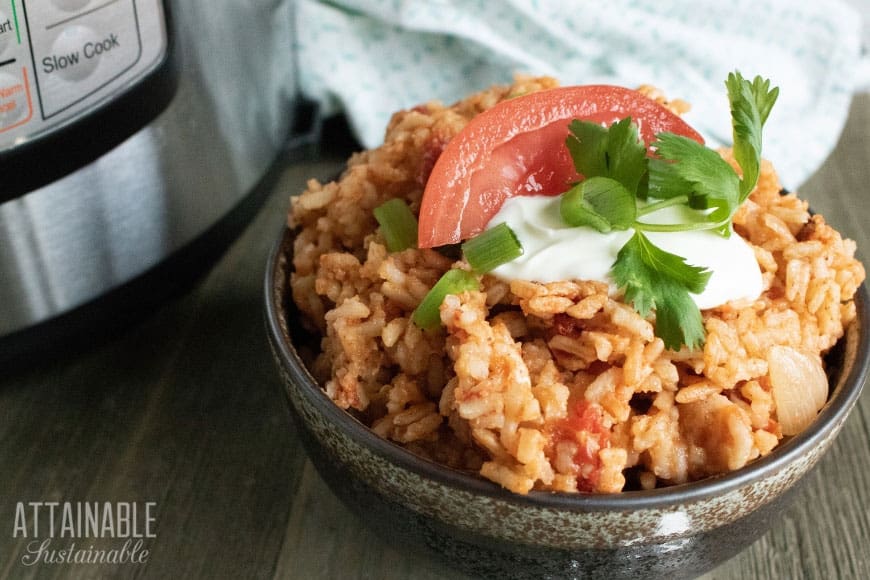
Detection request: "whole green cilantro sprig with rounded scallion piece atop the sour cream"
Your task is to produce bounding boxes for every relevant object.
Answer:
[560,72,779,350]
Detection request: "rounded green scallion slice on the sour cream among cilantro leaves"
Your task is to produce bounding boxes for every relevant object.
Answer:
[559,177,637,233]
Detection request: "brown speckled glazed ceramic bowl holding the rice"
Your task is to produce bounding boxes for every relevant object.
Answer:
[265,231,870,579]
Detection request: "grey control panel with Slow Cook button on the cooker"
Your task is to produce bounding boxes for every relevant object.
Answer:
[0,0,168,151]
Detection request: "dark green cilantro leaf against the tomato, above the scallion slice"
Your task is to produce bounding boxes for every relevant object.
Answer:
[566,117,647,195]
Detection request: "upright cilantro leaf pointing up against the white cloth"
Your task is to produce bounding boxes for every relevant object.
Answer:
[725,71,779,203]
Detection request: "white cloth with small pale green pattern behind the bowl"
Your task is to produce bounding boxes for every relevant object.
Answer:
[297,0,870,188]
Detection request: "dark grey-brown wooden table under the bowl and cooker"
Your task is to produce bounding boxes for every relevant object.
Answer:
[0,94,870,580]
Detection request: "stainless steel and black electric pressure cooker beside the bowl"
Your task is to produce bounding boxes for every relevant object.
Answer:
[0,0,296,355]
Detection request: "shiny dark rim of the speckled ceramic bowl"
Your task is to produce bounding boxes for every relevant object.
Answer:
[264,227,870,512]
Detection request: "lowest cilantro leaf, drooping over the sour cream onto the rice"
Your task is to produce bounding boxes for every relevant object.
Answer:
[611,231,712,350]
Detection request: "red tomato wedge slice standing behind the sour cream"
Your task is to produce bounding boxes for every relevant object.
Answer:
[418,85,704,248]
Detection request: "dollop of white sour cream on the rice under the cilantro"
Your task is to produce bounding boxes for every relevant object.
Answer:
[487,196,762,310]
